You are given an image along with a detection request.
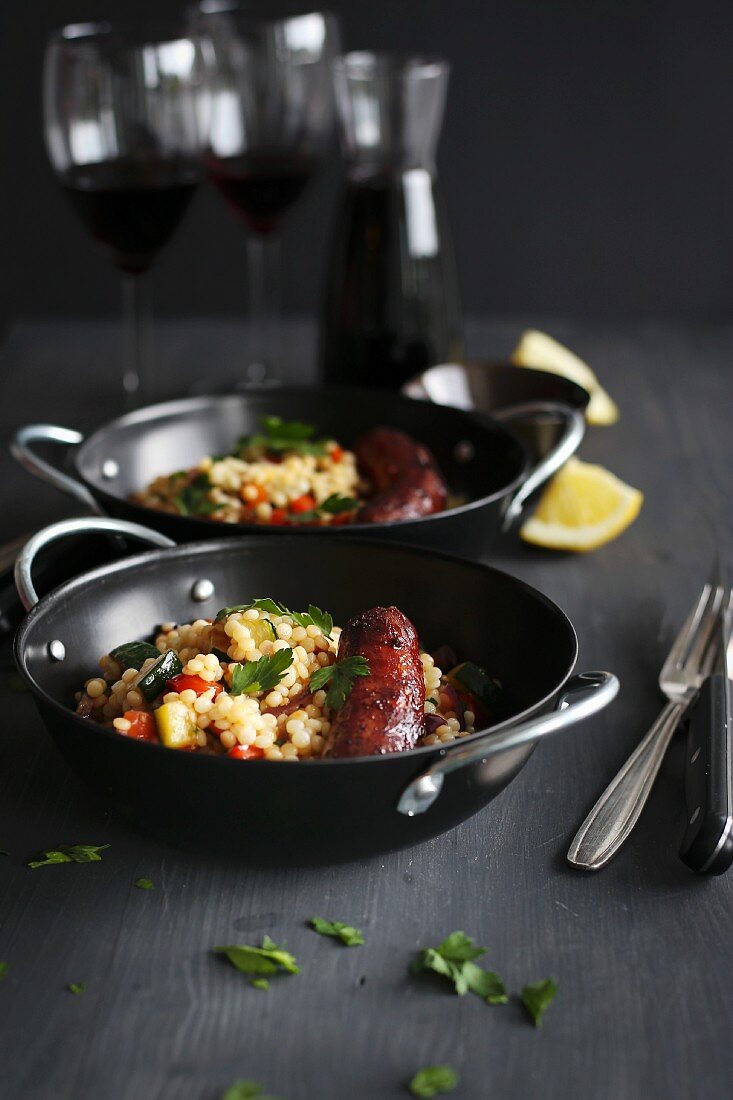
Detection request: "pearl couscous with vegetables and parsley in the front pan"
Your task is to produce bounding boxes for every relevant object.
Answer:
[75,598,496,760]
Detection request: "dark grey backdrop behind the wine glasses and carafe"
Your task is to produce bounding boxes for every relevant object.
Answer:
[0,0,733,328]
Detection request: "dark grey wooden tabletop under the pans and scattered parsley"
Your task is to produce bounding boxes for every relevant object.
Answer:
[0,318,733,1100]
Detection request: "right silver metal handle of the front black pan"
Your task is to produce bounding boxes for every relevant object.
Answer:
[397,672,620,817]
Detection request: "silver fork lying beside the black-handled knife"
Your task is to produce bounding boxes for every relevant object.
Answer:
[568,570,723,871]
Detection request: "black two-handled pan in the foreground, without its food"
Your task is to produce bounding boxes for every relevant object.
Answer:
[15,518,617,864]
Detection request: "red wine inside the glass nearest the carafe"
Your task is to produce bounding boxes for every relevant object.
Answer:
[209,152,316,237]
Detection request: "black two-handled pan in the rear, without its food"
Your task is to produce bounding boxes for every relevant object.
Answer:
[11,385,584,558]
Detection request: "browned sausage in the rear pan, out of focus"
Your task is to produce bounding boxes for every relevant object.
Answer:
[354,428,448,524]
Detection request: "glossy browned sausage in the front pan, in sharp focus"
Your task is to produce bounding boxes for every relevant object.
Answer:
[331,607,425,757]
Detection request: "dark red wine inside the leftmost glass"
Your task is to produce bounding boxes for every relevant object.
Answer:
[59,157,201,275]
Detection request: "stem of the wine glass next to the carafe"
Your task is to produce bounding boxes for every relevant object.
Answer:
[247,233,280,383]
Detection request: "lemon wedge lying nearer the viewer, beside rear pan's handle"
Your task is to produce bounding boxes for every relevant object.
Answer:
[519,459,644,551]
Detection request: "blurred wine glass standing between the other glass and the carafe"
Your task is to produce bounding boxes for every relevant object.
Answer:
[192,0,339,385]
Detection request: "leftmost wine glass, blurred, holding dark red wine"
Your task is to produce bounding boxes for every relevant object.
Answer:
[43,23,211,405]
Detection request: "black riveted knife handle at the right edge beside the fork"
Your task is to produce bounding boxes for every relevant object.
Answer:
[679,673,733,875]
